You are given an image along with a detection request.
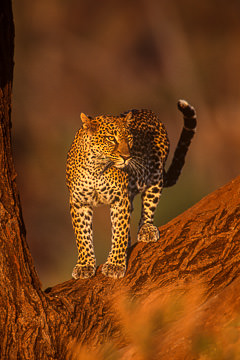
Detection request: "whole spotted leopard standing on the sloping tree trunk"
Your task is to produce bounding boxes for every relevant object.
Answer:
[66,100,197,279]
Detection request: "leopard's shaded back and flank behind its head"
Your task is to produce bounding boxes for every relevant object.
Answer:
[121,109,169,196]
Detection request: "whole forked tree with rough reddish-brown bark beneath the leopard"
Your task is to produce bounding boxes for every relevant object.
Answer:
[0,0,240,360]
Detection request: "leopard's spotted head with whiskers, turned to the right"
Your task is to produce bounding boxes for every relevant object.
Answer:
[81,112,133,168]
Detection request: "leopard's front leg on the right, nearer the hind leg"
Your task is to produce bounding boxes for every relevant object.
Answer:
[102,194,130,279]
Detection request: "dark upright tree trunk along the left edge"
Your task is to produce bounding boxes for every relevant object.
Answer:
[0,0,49,359]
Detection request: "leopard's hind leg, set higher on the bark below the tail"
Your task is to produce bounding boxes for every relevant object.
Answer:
[137,181,163,242]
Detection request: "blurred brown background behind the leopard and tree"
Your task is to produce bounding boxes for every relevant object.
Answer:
[12,0,240,287]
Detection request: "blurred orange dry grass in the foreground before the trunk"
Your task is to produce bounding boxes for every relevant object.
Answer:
[68,284,240,360]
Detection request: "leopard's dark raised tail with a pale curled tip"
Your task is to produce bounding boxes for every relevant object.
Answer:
[164,100,197,187]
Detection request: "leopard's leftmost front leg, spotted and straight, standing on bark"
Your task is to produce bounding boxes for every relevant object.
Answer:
[70,200,96,279]
